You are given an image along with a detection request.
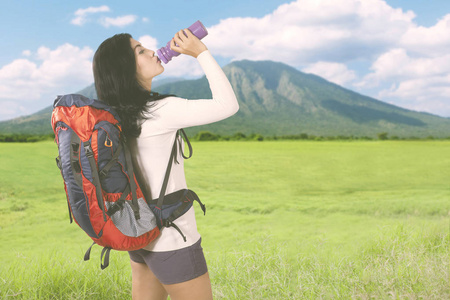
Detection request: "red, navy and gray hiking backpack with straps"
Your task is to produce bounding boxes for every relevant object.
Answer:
[51,94,206,269]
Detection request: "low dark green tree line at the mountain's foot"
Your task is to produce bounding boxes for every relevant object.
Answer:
[0,131,450,143]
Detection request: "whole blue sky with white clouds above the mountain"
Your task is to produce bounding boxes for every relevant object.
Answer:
[0,0,450,120]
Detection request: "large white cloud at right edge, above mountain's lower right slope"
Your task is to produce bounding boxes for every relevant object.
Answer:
[357,10,450,116]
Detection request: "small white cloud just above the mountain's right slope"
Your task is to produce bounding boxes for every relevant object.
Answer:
[302,61,356,85]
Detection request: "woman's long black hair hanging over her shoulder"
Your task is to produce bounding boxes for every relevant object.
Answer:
[93,33,167,137]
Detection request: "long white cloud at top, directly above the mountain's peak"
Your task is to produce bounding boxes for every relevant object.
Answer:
[206,0,415,67]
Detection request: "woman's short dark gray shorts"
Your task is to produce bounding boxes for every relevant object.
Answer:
[128,238,208,284]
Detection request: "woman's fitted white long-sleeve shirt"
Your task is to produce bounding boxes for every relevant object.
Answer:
[130,50,239,251]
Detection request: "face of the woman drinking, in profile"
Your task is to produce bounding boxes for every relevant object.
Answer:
[131,38,164,87]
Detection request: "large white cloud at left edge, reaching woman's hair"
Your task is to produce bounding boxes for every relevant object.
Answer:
[0,44,93,118]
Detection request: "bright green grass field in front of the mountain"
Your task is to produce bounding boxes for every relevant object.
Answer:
[0,141,450,299]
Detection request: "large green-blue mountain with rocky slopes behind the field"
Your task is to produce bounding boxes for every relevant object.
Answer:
[0,60,450,137]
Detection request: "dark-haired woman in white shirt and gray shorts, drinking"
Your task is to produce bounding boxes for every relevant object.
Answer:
[93,29,239,300]
